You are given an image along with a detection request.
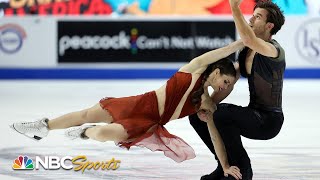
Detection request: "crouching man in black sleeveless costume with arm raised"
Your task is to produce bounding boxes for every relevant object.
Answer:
[189,0,285,180]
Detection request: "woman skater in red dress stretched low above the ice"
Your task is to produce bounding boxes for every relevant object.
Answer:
[11,40,243,179]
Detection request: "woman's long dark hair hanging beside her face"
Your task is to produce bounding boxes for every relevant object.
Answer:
[191,58,237,108]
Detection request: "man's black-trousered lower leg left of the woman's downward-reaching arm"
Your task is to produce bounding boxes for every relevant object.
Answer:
[189,114,223,180]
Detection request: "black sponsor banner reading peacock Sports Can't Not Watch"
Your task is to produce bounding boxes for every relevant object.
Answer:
[57,20,235,63]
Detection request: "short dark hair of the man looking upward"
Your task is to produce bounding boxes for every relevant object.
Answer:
[254,0,285,35]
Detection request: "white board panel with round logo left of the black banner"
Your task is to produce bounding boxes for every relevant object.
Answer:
[0,17,56,67]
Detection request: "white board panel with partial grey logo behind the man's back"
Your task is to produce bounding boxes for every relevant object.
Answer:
[274,16,320,68]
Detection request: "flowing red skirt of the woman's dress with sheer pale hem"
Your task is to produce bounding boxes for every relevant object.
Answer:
[100,91,195,162]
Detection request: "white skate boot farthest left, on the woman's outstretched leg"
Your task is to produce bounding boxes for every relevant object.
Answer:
[10,118,49,140]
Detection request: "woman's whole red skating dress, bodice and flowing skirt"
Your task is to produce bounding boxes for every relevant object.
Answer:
[100,72,202,162]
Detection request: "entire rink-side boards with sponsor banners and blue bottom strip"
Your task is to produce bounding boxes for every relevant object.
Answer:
[0,16,320,79]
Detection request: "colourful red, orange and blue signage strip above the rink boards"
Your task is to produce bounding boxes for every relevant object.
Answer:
[0,0,320,16]
